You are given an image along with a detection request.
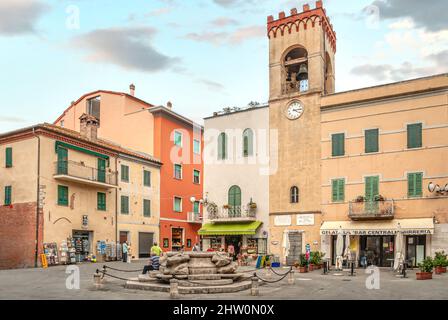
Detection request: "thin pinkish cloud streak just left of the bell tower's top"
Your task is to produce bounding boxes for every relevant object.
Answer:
[185,26,266,45]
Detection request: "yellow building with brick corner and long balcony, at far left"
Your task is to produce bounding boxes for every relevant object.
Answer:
[0,115,161,268]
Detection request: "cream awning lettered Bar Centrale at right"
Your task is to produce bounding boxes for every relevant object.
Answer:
[320,218,434,236]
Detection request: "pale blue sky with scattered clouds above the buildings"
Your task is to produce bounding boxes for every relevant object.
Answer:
[0,0,448,132]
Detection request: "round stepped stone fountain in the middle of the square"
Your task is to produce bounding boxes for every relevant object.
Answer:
[126,252,252,294]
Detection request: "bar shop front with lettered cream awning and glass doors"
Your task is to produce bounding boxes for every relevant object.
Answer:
[321,218,434,267]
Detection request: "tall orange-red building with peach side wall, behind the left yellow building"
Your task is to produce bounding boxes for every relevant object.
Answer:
[54,85,203,251]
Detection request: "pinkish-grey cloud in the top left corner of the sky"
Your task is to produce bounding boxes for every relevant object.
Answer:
[0,0,50,36]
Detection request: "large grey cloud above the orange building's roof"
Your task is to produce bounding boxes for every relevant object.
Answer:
[73,27,179,72]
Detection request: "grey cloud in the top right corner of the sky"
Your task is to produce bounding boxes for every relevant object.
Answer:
[366,0,448,31]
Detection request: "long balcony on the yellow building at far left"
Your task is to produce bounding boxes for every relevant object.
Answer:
[54,161,117,189]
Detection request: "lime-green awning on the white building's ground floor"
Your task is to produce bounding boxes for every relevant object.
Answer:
[199,221,262,236]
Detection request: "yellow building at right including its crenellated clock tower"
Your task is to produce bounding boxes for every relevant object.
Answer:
[268,1,448,266]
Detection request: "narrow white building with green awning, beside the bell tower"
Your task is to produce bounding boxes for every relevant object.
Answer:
[199,104,270,255]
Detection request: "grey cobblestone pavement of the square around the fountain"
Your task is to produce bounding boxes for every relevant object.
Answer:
[0,261,448,300]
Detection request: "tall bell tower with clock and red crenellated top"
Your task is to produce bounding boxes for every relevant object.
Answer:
[267,1,336,258]
